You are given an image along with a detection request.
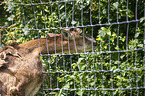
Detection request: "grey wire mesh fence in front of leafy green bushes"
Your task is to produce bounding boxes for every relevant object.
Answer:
[0,0,145,96]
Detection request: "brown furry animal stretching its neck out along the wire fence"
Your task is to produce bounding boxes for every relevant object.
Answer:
[0,28,96,96]
